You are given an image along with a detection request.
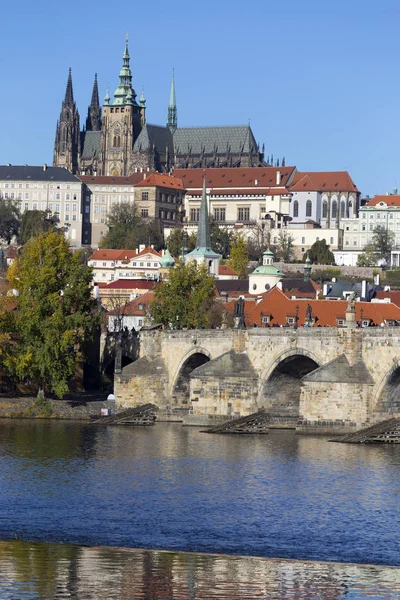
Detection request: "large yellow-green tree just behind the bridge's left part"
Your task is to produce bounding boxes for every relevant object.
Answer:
[151,261,215,329]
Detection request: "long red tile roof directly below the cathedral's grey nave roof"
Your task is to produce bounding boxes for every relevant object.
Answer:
[173,167,296,193]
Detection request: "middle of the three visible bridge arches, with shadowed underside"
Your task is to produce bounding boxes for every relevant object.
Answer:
[257,348,321,418]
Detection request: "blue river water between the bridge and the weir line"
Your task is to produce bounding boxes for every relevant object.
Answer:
[0,421,400,568]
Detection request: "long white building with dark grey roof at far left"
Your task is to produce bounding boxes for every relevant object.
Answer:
[0,165,83,248]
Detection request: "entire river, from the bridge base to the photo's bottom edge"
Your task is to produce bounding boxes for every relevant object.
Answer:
[0,420,400,600]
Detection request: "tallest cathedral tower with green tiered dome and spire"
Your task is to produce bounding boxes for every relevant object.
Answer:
[101,38,146,176]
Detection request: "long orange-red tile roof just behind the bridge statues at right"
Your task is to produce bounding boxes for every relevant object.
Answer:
[245,287,400,327]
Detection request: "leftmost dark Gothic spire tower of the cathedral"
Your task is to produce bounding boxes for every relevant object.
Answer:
[53,69,80,173]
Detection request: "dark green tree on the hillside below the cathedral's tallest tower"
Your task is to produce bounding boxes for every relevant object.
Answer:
[99,202,163,250]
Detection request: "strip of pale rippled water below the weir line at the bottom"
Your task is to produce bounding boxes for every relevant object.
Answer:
[0,541,400,600]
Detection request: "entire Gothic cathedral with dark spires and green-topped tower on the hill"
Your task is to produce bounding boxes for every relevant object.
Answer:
[53,40,269,176]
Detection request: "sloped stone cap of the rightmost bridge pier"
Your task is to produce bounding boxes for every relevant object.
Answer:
[302,354,374,385]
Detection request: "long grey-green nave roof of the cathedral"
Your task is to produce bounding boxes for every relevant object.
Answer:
[174,125,257,154]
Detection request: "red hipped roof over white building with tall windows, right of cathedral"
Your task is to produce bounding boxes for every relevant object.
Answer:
[289,171,359,192]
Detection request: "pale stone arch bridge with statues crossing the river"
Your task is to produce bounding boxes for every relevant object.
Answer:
[115,327,400,432]
